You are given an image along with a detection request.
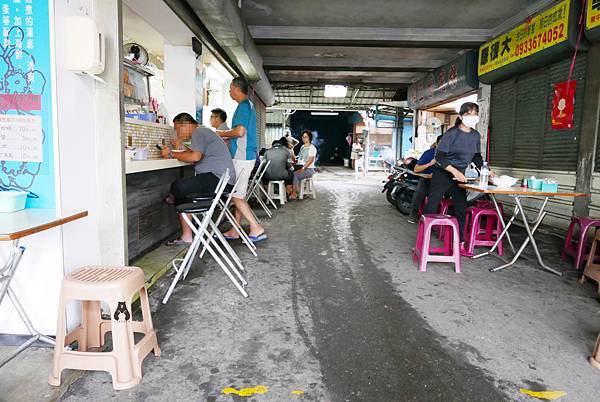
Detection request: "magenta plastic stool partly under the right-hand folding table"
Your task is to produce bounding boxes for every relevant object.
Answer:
[465,207,504,255]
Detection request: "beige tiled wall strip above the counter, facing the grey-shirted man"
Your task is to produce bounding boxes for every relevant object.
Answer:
[125,119,175,159]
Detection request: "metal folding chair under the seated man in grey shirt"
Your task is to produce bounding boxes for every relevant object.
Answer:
[163,169,248,304]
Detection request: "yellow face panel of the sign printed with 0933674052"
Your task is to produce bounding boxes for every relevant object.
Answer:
[478,0,572,75]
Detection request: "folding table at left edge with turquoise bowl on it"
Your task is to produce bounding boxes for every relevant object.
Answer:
[0,208,88,367]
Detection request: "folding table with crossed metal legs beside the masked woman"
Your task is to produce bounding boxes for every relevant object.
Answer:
[461,184,588,276]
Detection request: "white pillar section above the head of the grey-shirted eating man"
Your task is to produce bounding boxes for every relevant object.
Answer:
[164,45,196,120]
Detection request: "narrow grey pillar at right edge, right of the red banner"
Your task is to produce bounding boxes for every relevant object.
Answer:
[573,43,600,215]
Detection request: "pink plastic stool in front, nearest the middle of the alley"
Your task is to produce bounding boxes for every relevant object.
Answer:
[413,215,460,273]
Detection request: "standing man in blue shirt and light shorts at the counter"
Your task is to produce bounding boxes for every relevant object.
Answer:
[217,77,267,243]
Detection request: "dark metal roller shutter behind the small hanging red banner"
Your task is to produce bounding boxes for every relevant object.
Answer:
[490,53,586,171]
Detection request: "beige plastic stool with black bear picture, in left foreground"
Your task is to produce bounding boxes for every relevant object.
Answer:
[48,266,160,389]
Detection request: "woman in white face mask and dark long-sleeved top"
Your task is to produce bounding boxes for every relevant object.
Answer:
[424,102,483,255]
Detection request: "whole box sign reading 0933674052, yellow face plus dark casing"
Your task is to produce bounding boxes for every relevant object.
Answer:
[477,0,587,84]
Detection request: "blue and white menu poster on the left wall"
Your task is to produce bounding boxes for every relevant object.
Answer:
[0,0,55,208]
